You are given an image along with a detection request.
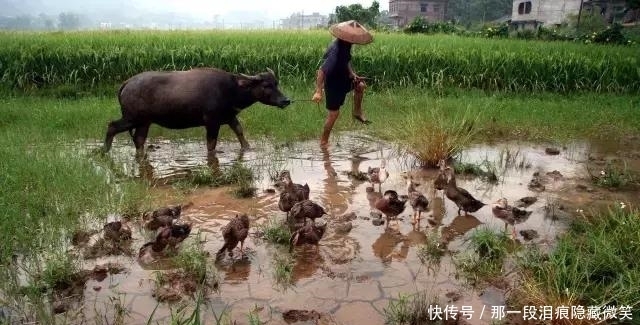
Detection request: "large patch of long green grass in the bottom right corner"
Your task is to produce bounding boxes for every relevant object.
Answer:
[516,205,640,314]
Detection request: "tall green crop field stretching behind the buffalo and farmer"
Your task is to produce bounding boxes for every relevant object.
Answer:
[0,31,640,93]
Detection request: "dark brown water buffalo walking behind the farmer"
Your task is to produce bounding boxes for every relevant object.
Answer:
[104,68,291,155]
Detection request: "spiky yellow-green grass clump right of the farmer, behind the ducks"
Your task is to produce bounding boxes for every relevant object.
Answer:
[379,108,479,167]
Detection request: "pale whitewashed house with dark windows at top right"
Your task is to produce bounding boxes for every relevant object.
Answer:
[511,0,625,29]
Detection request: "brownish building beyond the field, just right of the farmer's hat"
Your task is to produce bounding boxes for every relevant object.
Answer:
[389,0,449,27]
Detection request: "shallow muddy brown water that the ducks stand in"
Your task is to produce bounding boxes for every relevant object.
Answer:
[77,134,637,324]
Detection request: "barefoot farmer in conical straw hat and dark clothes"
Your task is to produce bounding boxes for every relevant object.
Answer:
[312,20,373,147]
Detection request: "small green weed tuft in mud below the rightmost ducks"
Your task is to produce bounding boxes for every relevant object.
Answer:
[454,227,509,285]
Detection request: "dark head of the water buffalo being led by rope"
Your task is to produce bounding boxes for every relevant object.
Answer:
[238,68,291,108]
